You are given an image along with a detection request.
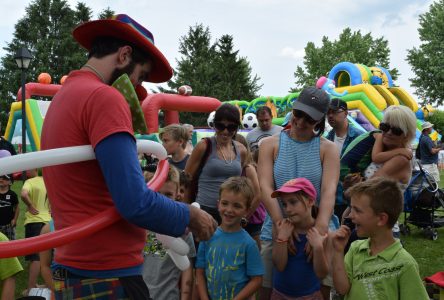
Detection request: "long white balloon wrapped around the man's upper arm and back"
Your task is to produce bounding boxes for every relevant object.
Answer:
[0,140,167,176]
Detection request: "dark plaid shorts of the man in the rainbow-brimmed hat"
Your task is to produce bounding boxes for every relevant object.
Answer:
[53,269,151,300]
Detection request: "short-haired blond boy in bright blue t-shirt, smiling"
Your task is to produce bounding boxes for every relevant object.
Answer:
[196,177,264,300]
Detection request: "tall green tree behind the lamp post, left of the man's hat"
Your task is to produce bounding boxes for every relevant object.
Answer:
[0,0,96,131]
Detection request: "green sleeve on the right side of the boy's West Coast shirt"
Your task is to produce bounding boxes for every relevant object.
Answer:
[398,258,429,300]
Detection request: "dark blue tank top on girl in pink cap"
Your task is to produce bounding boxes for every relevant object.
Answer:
[273,234,321,297]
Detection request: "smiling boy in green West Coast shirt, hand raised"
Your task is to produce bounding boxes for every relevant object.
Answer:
[331,177,429,300]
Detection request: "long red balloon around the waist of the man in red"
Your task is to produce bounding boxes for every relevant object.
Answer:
[0,160,168,258]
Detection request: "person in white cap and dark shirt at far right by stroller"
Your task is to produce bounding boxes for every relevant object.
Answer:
[418,122,441,183]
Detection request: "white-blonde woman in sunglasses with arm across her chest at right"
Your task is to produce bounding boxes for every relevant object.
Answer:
[364,106,416,187]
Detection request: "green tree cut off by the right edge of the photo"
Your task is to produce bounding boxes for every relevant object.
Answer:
[407,0,444,105]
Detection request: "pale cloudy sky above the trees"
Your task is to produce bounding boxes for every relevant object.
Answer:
[0,0,433,100]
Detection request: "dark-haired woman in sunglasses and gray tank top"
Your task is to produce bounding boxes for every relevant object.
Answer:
[185,103,247,224]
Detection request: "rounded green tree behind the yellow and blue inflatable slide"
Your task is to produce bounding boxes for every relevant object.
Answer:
[290,27,399,92]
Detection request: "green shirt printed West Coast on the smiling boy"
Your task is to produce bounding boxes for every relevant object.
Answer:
[345,239,429,300]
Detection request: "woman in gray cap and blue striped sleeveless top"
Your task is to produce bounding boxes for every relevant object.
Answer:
[258,87,339,299]
